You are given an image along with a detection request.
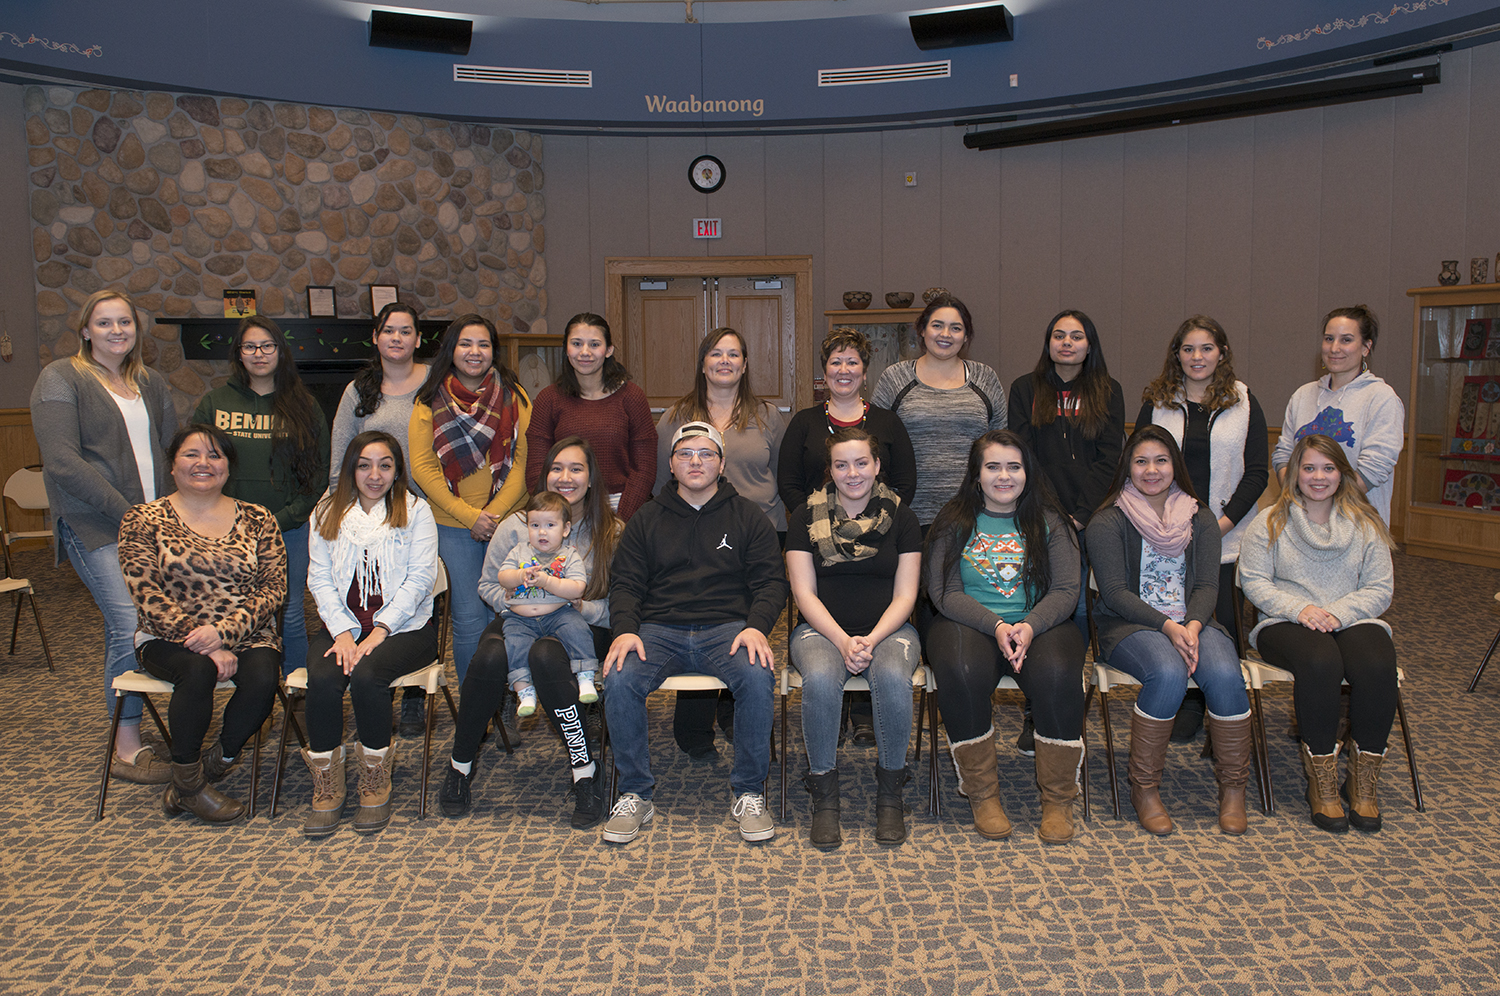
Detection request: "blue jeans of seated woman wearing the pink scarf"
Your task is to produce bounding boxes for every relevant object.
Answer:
[1109,626,1250,720]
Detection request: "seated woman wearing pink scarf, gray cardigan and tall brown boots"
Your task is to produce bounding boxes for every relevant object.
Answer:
[1085,425,1251,834]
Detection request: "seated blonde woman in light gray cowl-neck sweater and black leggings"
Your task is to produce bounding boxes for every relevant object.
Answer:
[1239,434,1397,834]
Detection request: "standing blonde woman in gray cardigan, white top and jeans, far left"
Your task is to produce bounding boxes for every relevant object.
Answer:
[32,291,177,785]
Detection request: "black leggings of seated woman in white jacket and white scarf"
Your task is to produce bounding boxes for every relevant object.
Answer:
[308,620,438,750]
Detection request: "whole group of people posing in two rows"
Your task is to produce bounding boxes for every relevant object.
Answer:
[32,283,1404,848]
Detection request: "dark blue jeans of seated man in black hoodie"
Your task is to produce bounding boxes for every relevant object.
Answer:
[605,623,776,800]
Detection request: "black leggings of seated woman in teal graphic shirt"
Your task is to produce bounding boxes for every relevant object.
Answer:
[926,615,1085,744]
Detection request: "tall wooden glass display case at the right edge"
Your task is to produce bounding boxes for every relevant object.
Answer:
[1401,284,1500,567]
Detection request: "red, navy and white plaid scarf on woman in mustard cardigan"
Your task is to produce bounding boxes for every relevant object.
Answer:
[432,371,521,504]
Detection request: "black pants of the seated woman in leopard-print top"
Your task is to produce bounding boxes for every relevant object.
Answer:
[135,641,281,765]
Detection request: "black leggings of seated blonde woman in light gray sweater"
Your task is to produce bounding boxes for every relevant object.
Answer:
[1256,623,1397,755]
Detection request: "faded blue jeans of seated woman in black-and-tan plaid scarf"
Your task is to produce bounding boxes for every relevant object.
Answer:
[791,623,921,774]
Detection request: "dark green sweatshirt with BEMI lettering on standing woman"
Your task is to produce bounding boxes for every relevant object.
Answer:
[192,381,329,533]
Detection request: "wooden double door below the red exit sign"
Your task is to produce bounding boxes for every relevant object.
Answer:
[606,257,812,410]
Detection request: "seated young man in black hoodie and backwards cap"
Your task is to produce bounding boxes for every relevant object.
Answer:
[605,422,788,843]
